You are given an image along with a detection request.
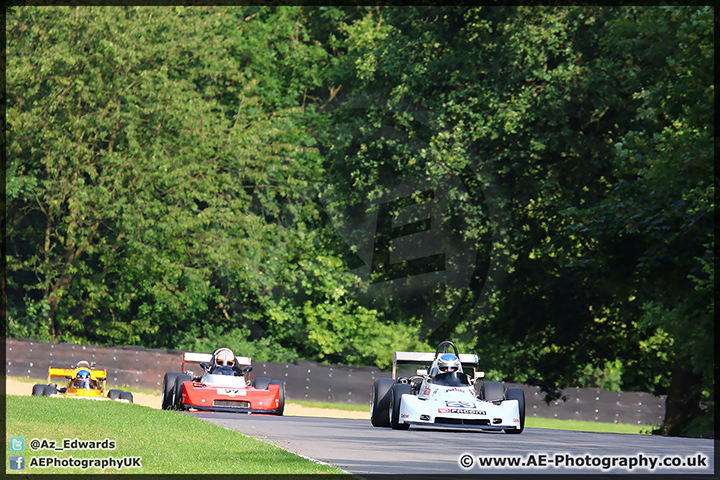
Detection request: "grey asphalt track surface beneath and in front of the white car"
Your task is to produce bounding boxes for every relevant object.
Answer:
[190,412,715,478]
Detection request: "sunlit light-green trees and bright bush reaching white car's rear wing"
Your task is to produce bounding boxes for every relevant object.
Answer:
[8,3,428,364]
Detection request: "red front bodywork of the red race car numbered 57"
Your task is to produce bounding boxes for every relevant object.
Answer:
[181,380,280,413]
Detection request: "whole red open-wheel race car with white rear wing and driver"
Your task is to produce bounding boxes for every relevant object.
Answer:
[162,348,285,415]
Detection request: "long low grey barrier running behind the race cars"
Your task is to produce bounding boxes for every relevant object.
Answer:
[5,339,665,425]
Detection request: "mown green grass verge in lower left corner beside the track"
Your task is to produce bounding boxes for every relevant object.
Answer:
[5,396,342,475]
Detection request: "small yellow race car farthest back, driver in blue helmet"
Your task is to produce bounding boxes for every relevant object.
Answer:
[33,361,133,403]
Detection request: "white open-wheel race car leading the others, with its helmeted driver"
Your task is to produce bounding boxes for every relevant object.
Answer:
[370,341,525,434]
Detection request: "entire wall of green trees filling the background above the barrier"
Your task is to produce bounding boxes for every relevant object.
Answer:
[6,6,715,434]
